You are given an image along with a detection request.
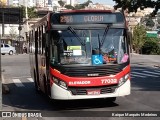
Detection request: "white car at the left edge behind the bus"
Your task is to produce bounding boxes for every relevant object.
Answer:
[1,44,16,55]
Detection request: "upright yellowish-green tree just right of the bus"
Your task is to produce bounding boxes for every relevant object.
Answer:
[133,24,146,53]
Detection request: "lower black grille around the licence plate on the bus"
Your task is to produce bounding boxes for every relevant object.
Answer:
[68,85,117,95]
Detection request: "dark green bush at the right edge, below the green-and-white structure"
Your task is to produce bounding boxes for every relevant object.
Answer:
[142,38,160,55]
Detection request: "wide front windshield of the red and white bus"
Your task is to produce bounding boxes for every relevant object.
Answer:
[50,27,128,65]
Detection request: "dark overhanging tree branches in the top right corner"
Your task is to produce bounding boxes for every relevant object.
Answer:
[113,0,160,16]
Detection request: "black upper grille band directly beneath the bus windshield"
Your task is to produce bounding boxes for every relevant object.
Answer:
[51,62,129,77]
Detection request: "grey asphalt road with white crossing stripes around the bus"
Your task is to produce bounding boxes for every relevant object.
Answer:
[2,54,160,120]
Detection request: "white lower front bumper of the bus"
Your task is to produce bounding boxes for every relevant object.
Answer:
[51,80,131,100]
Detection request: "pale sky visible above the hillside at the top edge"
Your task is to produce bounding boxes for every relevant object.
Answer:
[79,0,115,6]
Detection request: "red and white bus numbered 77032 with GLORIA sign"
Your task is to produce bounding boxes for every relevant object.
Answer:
[29,10,131,101]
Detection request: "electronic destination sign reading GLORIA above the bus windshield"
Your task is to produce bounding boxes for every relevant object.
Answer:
[59,13,124,24]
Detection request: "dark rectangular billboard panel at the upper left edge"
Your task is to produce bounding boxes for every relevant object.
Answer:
[0,8,23,24]
